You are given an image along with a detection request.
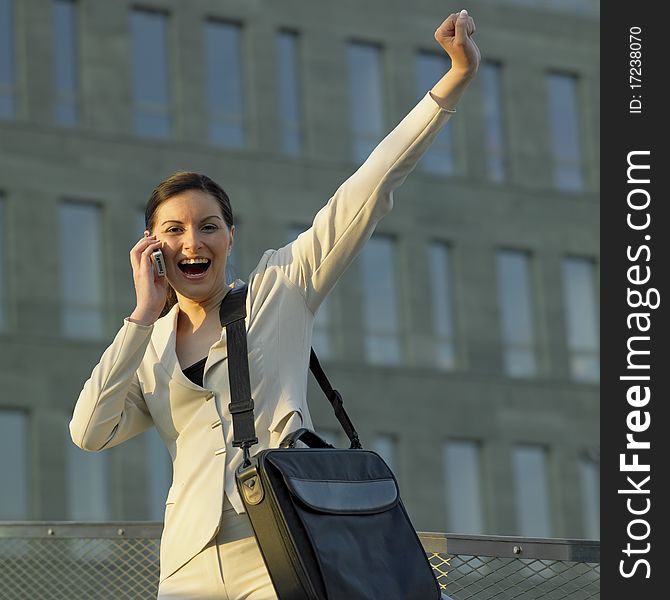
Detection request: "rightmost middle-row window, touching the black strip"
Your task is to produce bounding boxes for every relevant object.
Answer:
[563,258,600,382]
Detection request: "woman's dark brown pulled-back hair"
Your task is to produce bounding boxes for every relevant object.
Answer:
[144,171,234,317]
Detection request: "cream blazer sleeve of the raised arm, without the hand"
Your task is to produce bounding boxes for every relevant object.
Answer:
[267,93,451,312]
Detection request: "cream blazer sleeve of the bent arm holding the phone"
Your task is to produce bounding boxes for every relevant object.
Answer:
[70,319,153,452]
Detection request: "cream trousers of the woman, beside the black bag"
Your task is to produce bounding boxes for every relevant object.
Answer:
[157,497,277,600]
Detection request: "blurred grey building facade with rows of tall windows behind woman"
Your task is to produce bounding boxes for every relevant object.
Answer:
[0,0,599,538]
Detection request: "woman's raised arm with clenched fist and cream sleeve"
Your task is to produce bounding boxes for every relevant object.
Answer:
[264,11,480,311]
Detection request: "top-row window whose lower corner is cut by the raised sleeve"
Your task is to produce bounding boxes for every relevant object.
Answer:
[347,42,384,163]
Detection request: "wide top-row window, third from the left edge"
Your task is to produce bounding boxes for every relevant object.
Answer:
[130,9,170,138]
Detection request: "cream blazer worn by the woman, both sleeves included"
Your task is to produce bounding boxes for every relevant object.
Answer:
[70,94,450,581]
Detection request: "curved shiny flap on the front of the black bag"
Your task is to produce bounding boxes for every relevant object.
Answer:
[285,477,399,514]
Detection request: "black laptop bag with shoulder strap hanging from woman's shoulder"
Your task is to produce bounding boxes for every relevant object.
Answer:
[221,286,440,600]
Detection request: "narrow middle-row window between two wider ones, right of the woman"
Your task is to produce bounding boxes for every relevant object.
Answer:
[429,242,456,369]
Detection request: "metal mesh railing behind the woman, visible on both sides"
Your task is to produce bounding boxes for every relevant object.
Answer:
[0,521,600,600]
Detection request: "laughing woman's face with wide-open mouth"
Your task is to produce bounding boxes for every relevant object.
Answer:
[151,190,235,301]
